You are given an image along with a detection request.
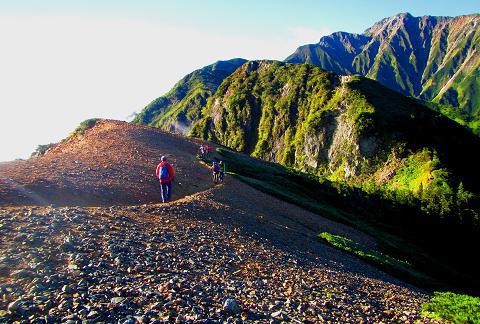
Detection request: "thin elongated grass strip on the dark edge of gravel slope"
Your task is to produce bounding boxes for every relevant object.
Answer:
[318,232,434,284]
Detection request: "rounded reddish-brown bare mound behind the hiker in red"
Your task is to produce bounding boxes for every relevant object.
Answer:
[0,120,210,206]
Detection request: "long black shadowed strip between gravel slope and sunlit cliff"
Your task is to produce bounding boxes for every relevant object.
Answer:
[219,149,480,293]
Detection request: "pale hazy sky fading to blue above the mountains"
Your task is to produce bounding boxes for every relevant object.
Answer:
[0,0,480,161]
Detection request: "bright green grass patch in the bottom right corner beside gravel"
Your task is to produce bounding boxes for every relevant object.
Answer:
[422,292,480,323]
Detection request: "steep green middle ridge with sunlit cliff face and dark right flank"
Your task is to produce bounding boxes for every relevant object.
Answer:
[191,61,480,191]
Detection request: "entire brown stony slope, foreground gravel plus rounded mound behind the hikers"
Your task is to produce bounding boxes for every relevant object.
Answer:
[0,120,429,323]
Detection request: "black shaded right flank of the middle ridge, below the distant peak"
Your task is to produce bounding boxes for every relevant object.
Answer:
[349,78,480,192]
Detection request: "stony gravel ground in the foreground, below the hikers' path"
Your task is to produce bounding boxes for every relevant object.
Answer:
[0,180,428,323]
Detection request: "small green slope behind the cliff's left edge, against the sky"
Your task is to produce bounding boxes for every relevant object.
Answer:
[133,59,246,133]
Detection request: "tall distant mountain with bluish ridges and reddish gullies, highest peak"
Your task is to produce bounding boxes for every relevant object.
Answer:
[286,13,480,133]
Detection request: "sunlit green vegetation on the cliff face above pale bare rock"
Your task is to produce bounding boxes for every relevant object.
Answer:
[191,61,375,175]
